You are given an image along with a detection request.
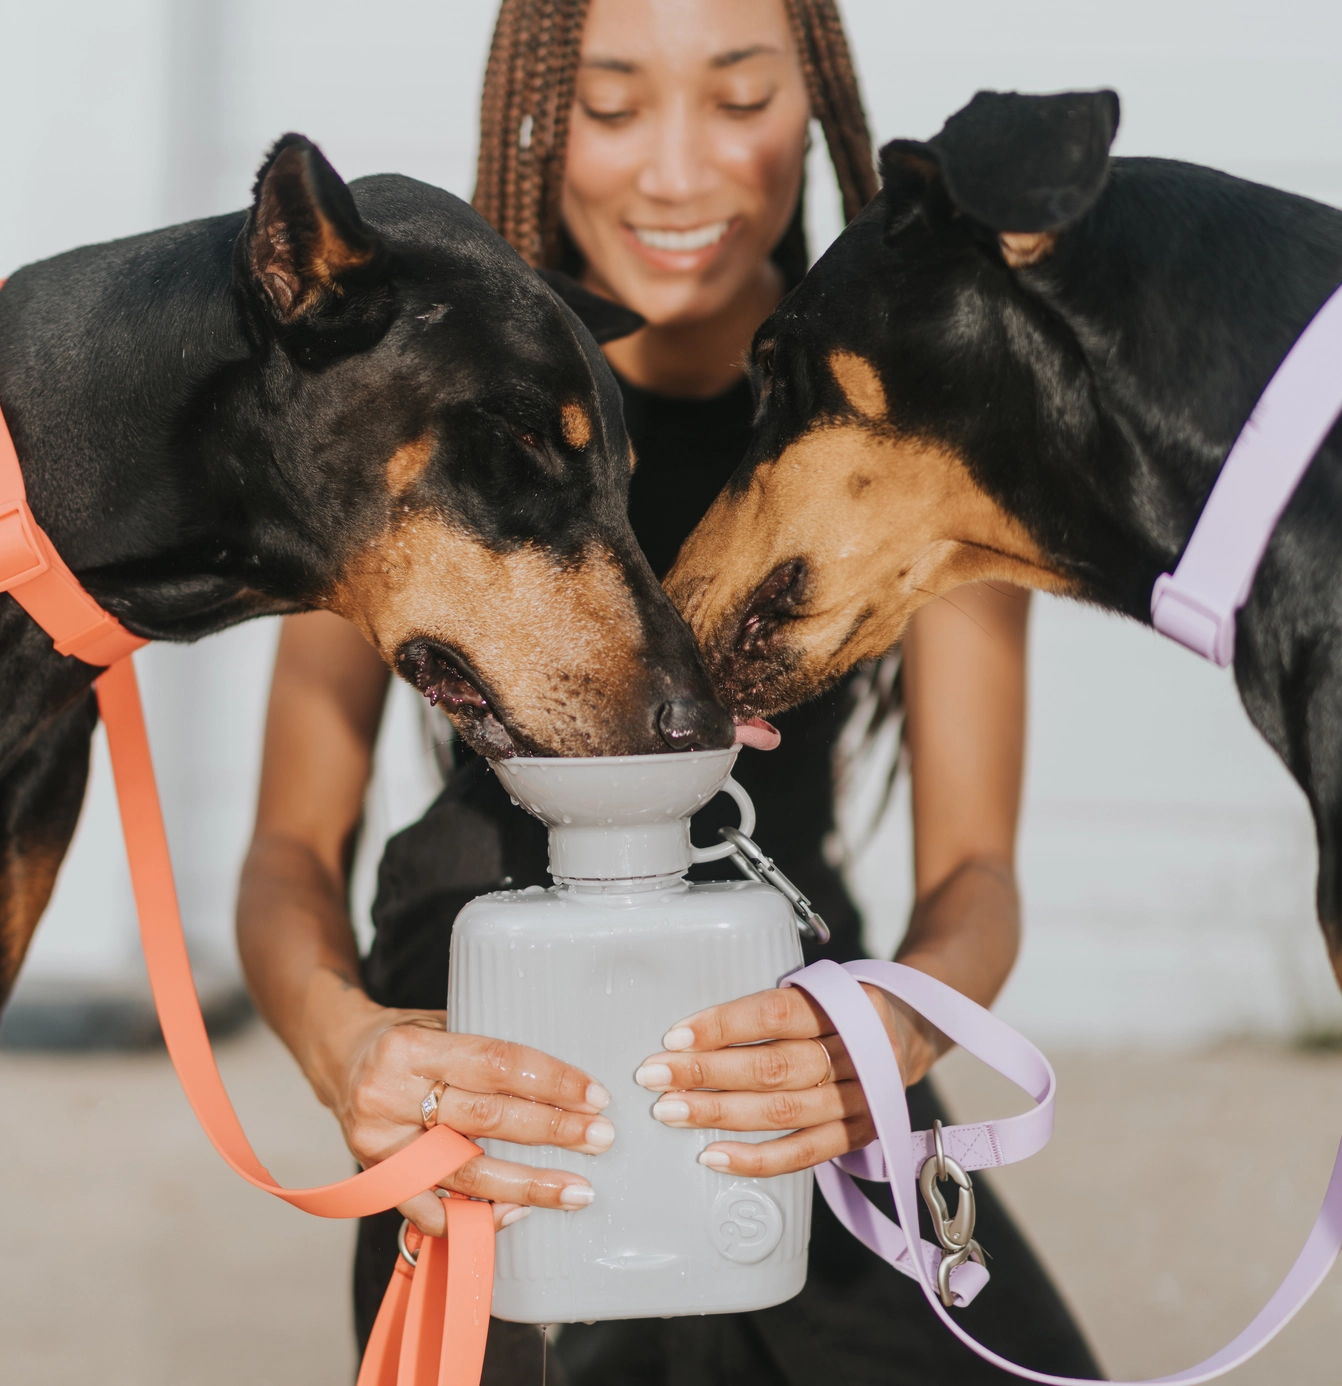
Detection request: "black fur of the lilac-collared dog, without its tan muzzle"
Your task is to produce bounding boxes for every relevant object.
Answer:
[733,93,1342,959]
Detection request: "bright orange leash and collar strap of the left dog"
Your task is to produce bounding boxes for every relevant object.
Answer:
[0,280,494,1386]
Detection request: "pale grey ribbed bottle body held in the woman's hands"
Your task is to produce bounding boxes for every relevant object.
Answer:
[448,881,812,1324]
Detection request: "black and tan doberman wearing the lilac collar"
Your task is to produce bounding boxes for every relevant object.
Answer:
[667,91,1342,977]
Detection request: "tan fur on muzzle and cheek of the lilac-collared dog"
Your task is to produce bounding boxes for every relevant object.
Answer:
[665,423,1069,714]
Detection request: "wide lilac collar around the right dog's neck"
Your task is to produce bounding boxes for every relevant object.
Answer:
[1151,277,1342,668]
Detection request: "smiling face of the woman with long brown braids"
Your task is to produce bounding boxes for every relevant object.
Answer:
[563,0,810,324]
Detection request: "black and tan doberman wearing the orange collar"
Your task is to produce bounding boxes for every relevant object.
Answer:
[0,134,733,999]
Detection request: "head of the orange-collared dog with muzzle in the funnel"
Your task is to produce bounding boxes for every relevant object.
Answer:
[234,136,732,757]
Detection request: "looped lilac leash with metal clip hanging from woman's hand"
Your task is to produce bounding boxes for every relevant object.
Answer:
[783,960,1342,1386]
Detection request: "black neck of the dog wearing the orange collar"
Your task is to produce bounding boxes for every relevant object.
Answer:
[0,213,302,639]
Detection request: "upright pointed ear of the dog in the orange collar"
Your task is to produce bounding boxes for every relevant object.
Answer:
[243,134,388,324]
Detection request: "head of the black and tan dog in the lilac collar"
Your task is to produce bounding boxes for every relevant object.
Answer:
[667,91,1119,715]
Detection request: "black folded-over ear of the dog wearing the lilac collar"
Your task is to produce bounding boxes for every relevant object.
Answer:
[882,91,1119,267]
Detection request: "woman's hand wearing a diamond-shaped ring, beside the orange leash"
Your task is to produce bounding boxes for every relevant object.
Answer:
[313,988,616,1236]
